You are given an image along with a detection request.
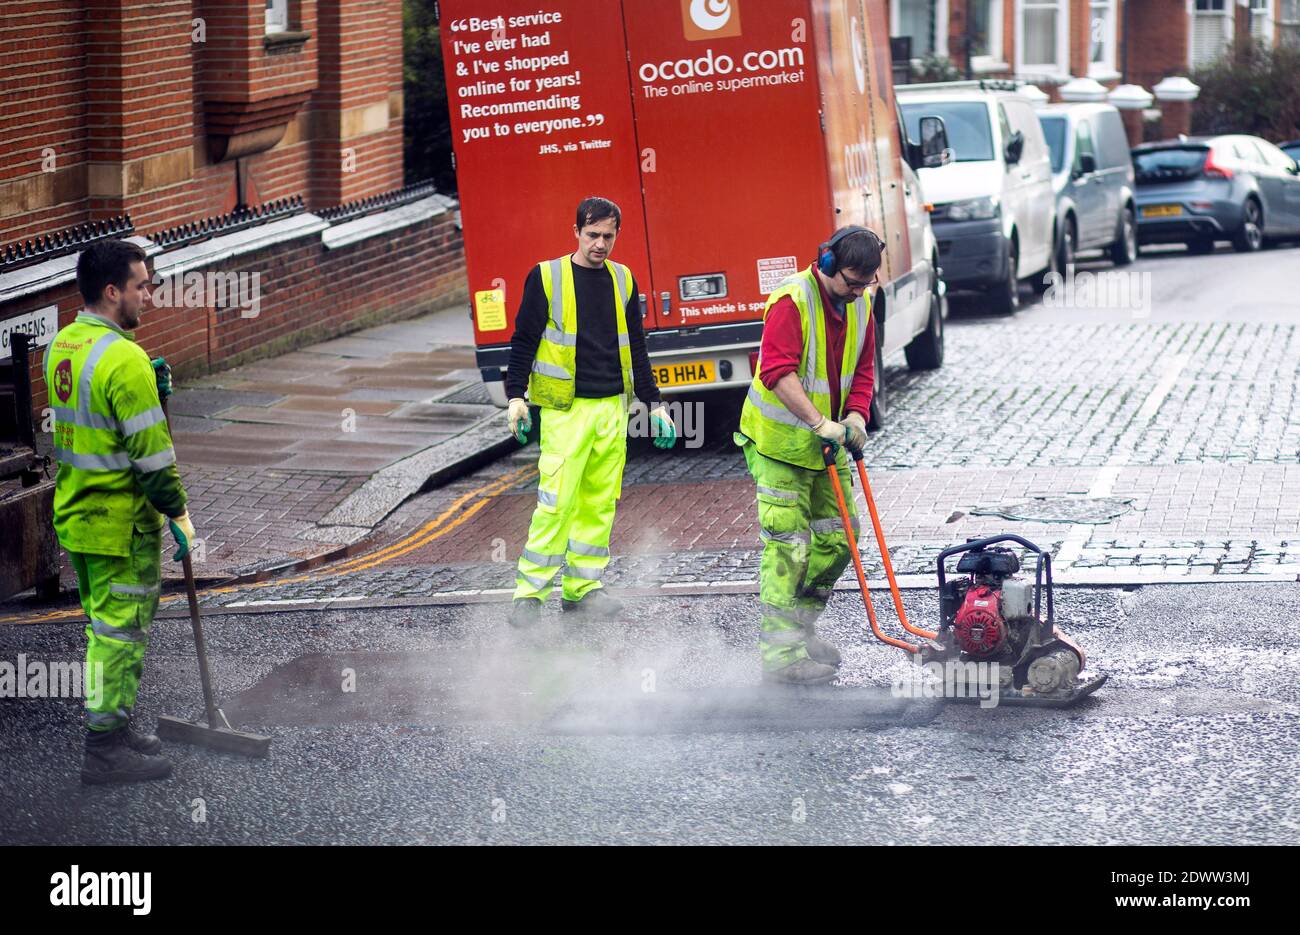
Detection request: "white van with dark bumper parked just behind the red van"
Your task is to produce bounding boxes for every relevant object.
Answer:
[896,81,1056,313]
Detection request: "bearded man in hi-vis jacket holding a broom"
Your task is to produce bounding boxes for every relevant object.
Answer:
[46,241,195,783]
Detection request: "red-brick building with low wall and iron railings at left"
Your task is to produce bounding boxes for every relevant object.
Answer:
[0,0,465,408]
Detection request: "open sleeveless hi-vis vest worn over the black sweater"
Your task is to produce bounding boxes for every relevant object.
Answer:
[528,255,632,410]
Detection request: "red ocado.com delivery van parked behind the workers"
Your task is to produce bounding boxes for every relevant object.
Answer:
[439,0,946,423]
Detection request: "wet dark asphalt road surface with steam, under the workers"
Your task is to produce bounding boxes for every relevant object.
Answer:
[0,584,1300,844]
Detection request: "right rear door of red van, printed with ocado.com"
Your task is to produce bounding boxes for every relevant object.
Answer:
[618,0,828,329]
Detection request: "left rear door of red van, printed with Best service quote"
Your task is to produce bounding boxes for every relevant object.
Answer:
[439,0,650,348]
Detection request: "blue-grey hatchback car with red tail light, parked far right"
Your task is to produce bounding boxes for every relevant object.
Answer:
[1132,135,1300,254]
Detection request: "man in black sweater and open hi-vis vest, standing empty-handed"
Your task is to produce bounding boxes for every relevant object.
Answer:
[506,198,677,627]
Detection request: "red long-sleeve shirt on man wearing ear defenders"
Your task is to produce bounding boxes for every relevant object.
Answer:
[759,273,876,420]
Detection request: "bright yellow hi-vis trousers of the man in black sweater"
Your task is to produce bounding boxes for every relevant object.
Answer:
[515,395,628,601]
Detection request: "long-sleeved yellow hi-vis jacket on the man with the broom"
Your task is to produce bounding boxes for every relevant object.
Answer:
[46,311,186,557]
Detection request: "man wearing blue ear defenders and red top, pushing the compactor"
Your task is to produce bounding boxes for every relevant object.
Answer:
[736,226,884,685]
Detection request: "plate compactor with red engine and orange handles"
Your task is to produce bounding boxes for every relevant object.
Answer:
[822,446,1106,707]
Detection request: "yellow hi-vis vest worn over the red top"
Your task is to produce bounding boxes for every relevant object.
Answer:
[740,268,871,471]
